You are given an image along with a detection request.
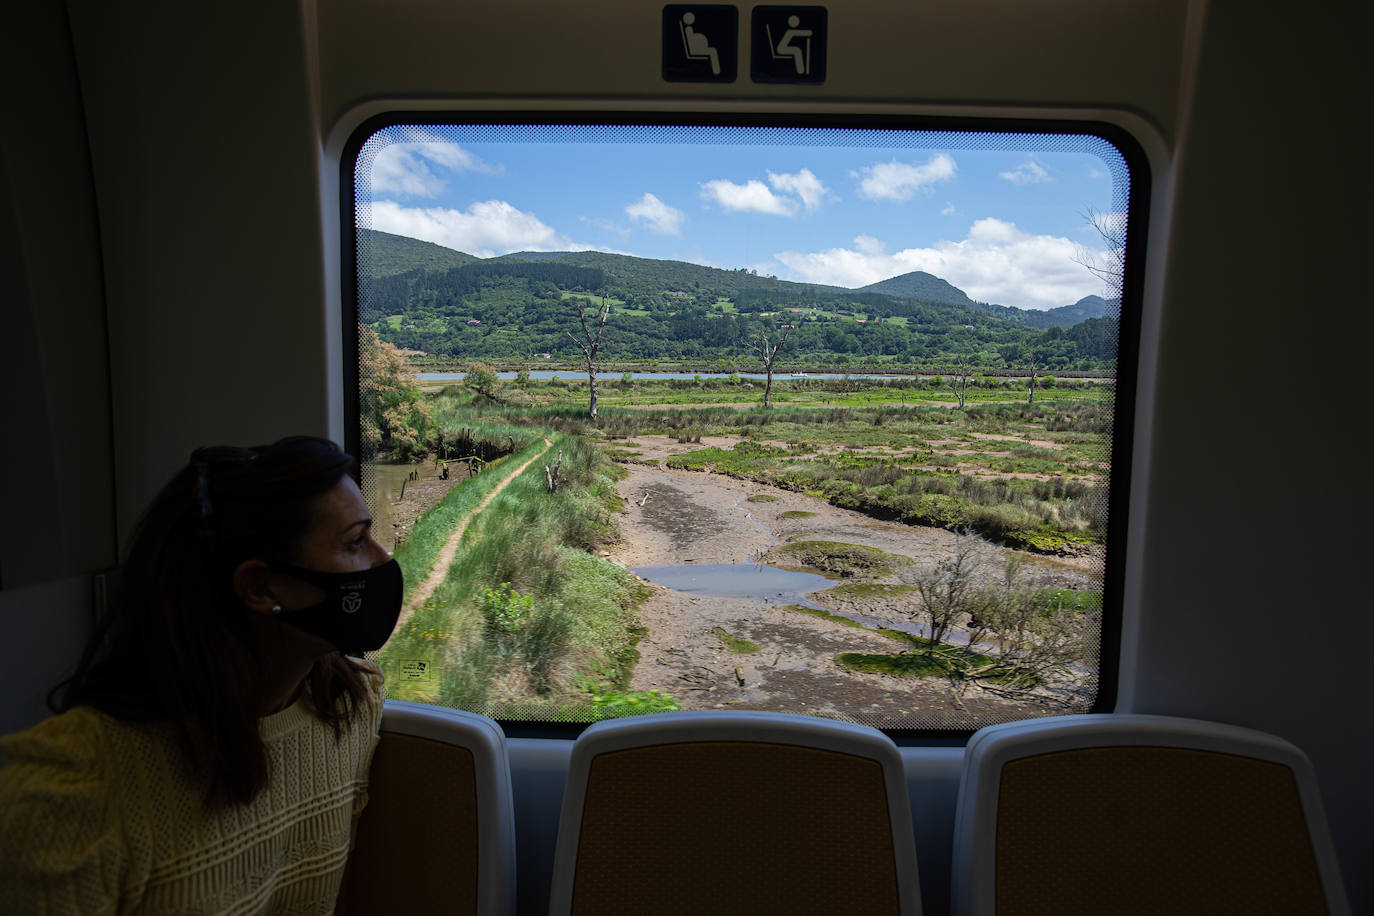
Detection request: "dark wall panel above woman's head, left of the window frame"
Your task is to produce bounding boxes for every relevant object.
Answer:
[69,0,339,549]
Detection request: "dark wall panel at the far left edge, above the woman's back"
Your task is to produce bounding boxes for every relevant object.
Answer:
[0,1,114,589]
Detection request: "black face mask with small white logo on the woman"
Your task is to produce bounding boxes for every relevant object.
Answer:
[276,560,405,655]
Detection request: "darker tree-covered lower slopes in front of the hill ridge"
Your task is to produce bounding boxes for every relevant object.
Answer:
[361,269,1116,371]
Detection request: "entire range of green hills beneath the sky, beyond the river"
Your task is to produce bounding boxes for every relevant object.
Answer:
[360,243,1116,371]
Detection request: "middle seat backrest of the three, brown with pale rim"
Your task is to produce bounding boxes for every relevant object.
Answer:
[550,711,921,915]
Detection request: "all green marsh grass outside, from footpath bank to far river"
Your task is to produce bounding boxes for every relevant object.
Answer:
[378,365,1114,721]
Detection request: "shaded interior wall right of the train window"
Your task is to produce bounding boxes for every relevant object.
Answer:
[1120,3,1374,913]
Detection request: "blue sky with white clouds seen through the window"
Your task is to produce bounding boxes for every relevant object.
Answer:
[359,126,1121,309]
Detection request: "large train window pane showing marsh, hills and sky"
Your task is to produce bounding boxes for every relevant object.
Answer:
[344,114,1147,735]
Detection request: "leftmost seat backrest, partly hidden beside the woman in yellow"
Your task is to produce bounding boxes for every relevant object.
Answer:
[344,700,515,915]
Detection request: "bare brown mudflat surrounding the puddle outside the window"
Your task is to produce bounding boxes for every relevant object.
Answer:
[609,435,1096,728]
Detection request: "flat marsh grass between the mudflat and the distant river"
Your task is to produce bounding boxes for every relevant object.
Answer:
[440,379,1114,553]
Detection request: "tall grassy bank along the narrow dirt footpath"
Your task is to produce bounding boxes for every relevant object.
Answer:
[376,433,656,718]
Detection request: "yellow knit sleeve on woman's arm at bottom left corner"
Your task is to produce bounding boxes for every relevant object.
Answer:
[0,707,126,916]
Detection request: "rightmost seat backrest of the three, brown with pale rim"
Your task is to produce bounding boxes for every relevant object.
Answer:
[951,715,1348,916]
